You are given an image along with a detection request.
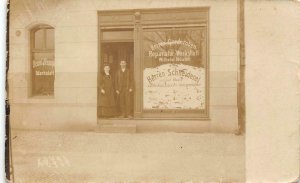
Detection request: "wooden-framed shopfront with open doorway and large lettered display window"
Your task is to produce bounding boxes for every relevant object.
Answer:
[98,8,209,119]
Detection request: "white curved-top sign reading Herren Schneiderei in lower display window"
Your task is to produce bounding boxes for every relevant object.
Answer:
[144,63,205,109]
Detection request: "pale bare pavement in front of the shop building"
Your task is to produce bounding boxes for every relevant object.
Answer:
[12,130,245,183]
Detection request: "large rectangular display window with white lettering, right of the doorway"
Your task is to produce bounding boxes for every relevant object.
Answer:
[143,28,207,113]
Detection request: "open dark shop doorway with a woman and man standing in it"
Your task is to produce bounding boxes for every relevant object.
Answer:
[97,41,134,119]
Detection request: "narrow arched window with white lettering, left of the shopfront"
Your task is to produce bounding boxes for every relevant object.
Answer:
[30,25,55,96]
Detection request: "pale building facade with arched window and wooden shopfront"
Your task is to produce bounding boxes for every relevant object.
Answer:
[8,0,244,133]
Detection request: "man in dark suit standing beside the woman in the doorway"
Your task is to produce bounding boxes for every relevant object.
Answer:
[115,60,133,118]
